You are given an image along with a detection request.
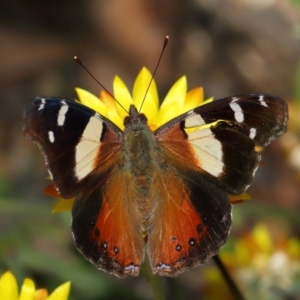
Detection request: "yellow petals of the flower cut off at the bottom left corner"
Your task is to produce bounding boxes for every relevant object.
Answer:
[0,272,71,300]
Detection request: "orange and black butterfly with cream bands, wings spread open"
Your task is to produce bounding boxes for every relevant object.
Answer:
[24,94,288,277]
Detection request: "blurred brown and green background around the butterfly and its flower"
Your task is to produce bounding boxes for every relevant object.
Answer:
[0,0,300,300]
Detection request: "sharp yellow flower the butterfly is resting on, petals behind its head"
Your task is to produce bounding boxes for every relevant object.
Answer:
[45,67,250,212]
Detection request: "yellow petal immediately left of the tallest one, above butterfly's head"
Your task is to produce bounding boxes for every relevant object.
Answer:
[113,76,133,120]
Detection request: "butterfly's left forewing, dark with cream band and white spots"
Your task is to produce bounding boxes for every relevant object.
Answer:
[24,97,123,198]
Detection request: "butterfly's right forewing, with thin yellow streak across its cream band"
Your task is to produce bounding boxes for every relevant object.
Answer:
[155,95,288,194]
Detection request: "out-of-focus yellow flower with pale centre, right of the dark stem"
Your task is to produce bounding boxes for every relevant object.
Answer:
[205,223,300,299]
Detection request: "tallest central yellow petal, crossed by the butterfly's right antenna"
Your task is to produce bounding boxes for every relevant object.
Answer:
[132,67,159,127]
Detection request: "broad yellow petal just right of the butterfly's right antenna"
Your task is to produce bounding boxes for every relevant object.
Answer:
[158,76,187,126]
